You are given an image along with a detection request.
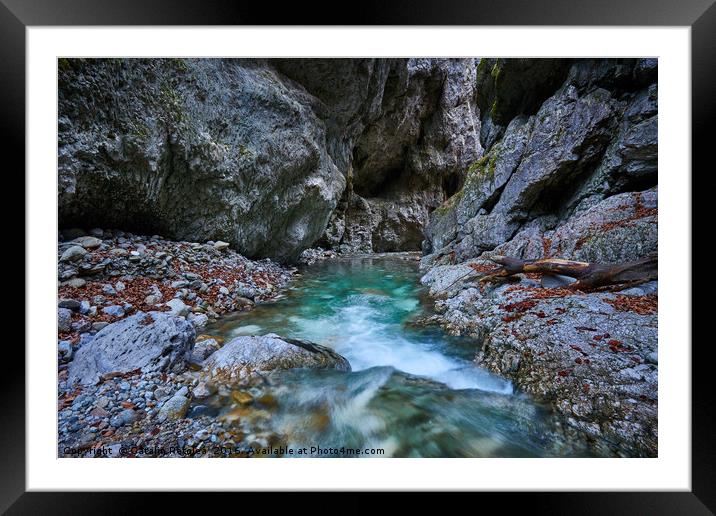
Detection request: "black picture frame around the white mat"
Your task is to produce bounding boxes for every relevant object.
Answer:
[0,0,716,515]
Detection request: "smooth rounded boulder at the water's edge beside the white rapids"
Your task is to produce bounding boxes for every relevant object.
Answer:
[203,334,351,378]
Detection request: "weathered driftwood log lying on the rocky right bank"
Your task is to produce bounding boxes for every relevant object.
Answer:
[480,254,658,290]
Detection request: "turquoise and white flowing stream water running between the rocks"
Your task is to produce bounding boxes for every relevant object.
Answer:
[201,257,592,457]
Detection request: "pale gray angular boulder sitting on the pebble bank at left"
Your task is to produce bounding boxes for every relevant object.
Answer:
[68,312,196,384]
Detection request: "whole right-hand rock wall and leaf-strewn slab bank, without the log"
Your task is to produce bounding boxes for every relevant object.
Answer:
[421,59,658,456]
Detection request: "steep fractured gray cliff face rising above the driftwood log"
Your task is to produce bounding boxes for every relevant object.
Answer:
[423,59,657,263]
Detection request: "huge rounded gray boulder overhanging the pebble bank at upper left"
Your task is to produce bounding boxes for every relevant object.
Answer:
[58,59,345,259]
